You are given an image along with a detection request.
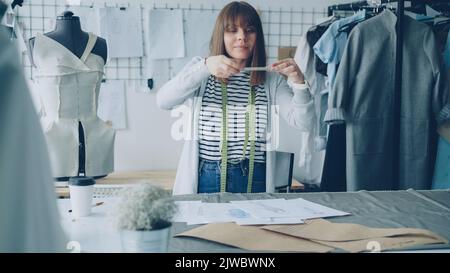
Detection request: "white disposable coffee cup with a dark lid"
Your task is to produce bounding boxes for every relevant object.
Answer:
[69,176,95,217]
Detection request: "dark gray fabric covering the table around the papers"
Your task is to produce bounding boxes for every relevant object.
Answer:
[169,190,450,252]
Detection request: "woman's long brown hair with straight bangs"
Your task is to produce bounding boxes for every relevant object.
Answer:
[209,1,266,85]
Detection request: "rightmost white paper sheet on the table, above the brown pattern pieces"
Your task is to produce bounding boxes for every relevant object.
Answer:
[286,198,350,219]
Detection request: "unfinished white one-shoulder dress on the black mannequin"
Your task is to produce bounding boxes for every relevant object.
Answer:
[33,33,115,177]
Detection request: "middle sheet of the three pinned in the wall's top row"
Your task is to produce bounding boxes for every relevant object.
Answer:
[148,9,185,59]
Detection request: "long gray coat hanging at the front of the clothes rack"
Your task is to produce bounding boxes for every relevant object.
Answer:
[325,10,450,191]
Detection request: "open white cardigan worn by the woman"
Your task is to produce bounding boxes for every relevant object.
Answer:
[156,57,316,195]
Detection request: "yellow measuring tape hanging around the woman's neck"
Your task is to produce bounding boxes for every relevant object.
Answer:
[220,83,256,193]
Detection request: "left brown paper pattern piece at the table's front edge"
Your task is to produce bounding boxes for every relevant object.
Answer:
[175,223,334,252]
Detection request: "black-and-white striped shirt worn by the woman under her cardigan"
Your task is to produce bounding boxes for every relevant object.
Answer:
[199,72,268,162]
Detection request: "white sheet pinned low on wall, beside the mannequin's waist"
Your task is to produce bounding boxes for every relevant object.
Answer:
[97,80,127,129]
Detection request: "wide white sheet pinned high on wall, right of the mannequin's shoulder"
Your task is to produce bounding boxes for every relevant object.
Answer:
[99,8,144,58]
